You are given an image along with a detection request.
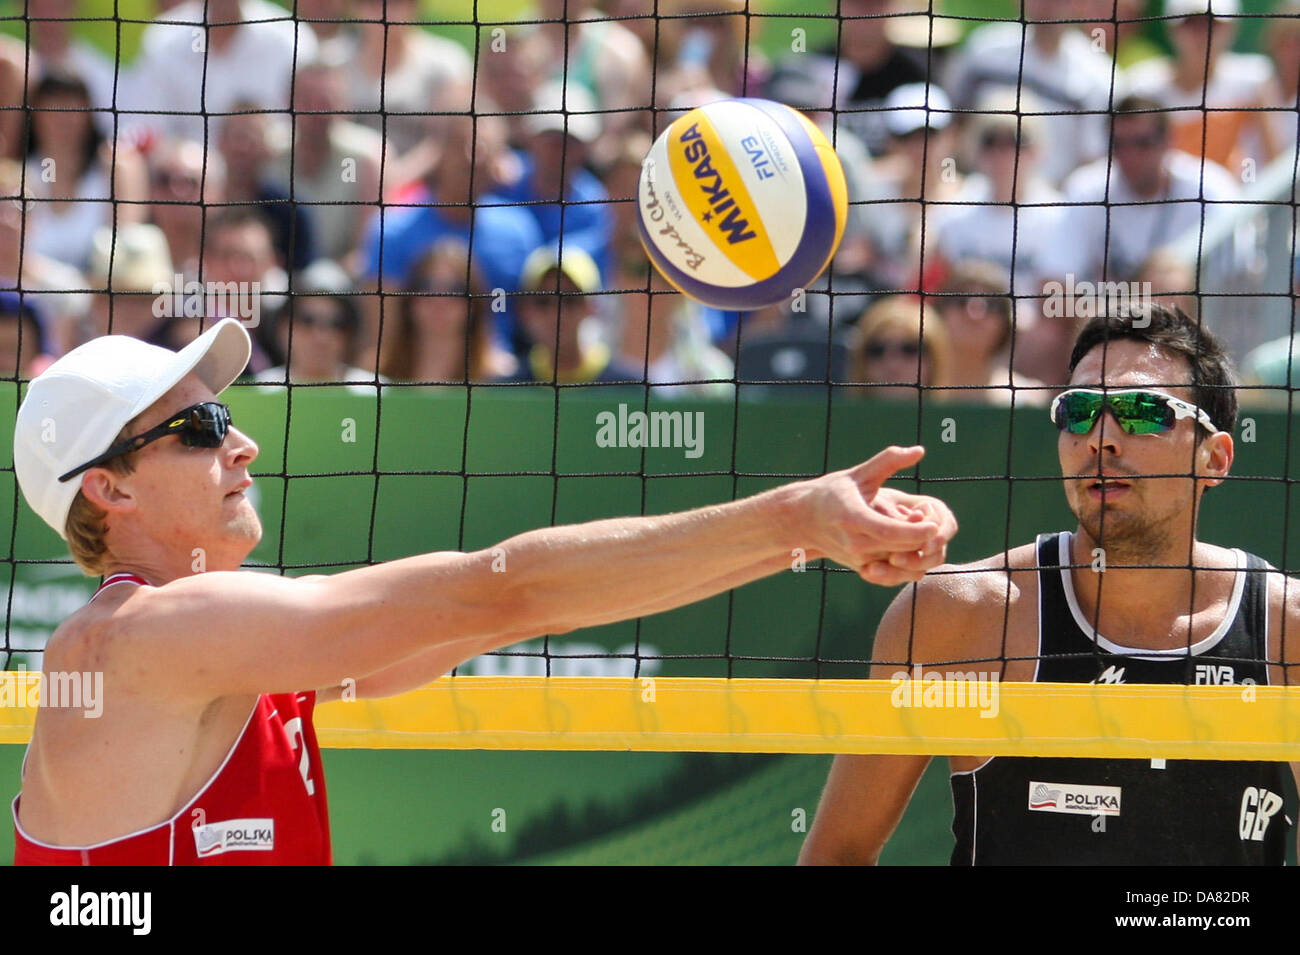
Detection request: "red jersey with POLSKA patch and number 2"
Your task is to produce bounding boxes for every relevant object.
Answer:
[13,574,332,865]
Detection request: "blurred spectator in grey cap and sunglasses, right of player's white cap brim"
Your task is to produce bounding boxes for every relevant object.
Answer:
[254,259,377,395]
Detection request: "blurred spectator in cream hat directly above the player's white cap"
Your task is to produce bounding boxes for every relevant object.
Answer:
[78,222,183,344]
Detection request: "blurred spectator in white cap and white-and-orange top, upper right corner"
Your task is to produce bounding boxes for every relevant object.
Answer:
[1127,0,1279,169]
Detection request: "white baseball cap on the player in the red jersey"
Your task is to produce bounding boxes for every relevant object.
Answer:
[13,318,252,539]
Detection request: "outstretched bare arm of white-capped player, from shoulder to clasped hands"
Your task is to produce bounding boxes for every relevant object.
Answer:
[98,448,956,699]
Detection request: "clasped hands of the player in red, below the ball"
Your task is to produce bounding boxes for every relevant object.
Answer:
[809,446,957,587]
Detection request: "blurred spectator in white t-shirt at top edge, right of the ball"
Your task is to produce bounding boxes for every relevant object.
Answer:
[944,0,1123,185]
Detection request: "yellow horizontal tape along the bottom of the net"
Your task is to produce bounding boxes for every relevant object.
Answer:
[0,673,1300,760]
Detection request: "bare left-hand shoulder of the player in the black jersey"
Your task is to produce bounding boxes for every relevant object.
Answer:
[872,544,1037,664]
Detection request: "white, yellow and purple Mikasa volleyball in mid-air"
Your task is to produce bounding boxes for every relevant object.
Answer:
[637,99,848,311]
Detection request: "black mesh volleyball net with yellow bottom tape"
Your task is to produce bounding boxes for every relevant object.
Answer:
[0,0,1300,759]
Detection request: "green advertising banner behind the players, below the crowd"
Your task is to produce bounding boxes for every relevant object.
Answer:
[0,386,1297,864]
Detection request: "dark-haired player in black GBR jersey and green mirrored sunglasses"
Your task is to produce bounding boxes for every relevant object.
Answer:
[801,305,1300,865]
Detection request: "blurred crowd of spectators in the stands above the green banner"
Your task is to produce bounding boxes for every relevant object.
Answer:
[0,0,1300,404]
